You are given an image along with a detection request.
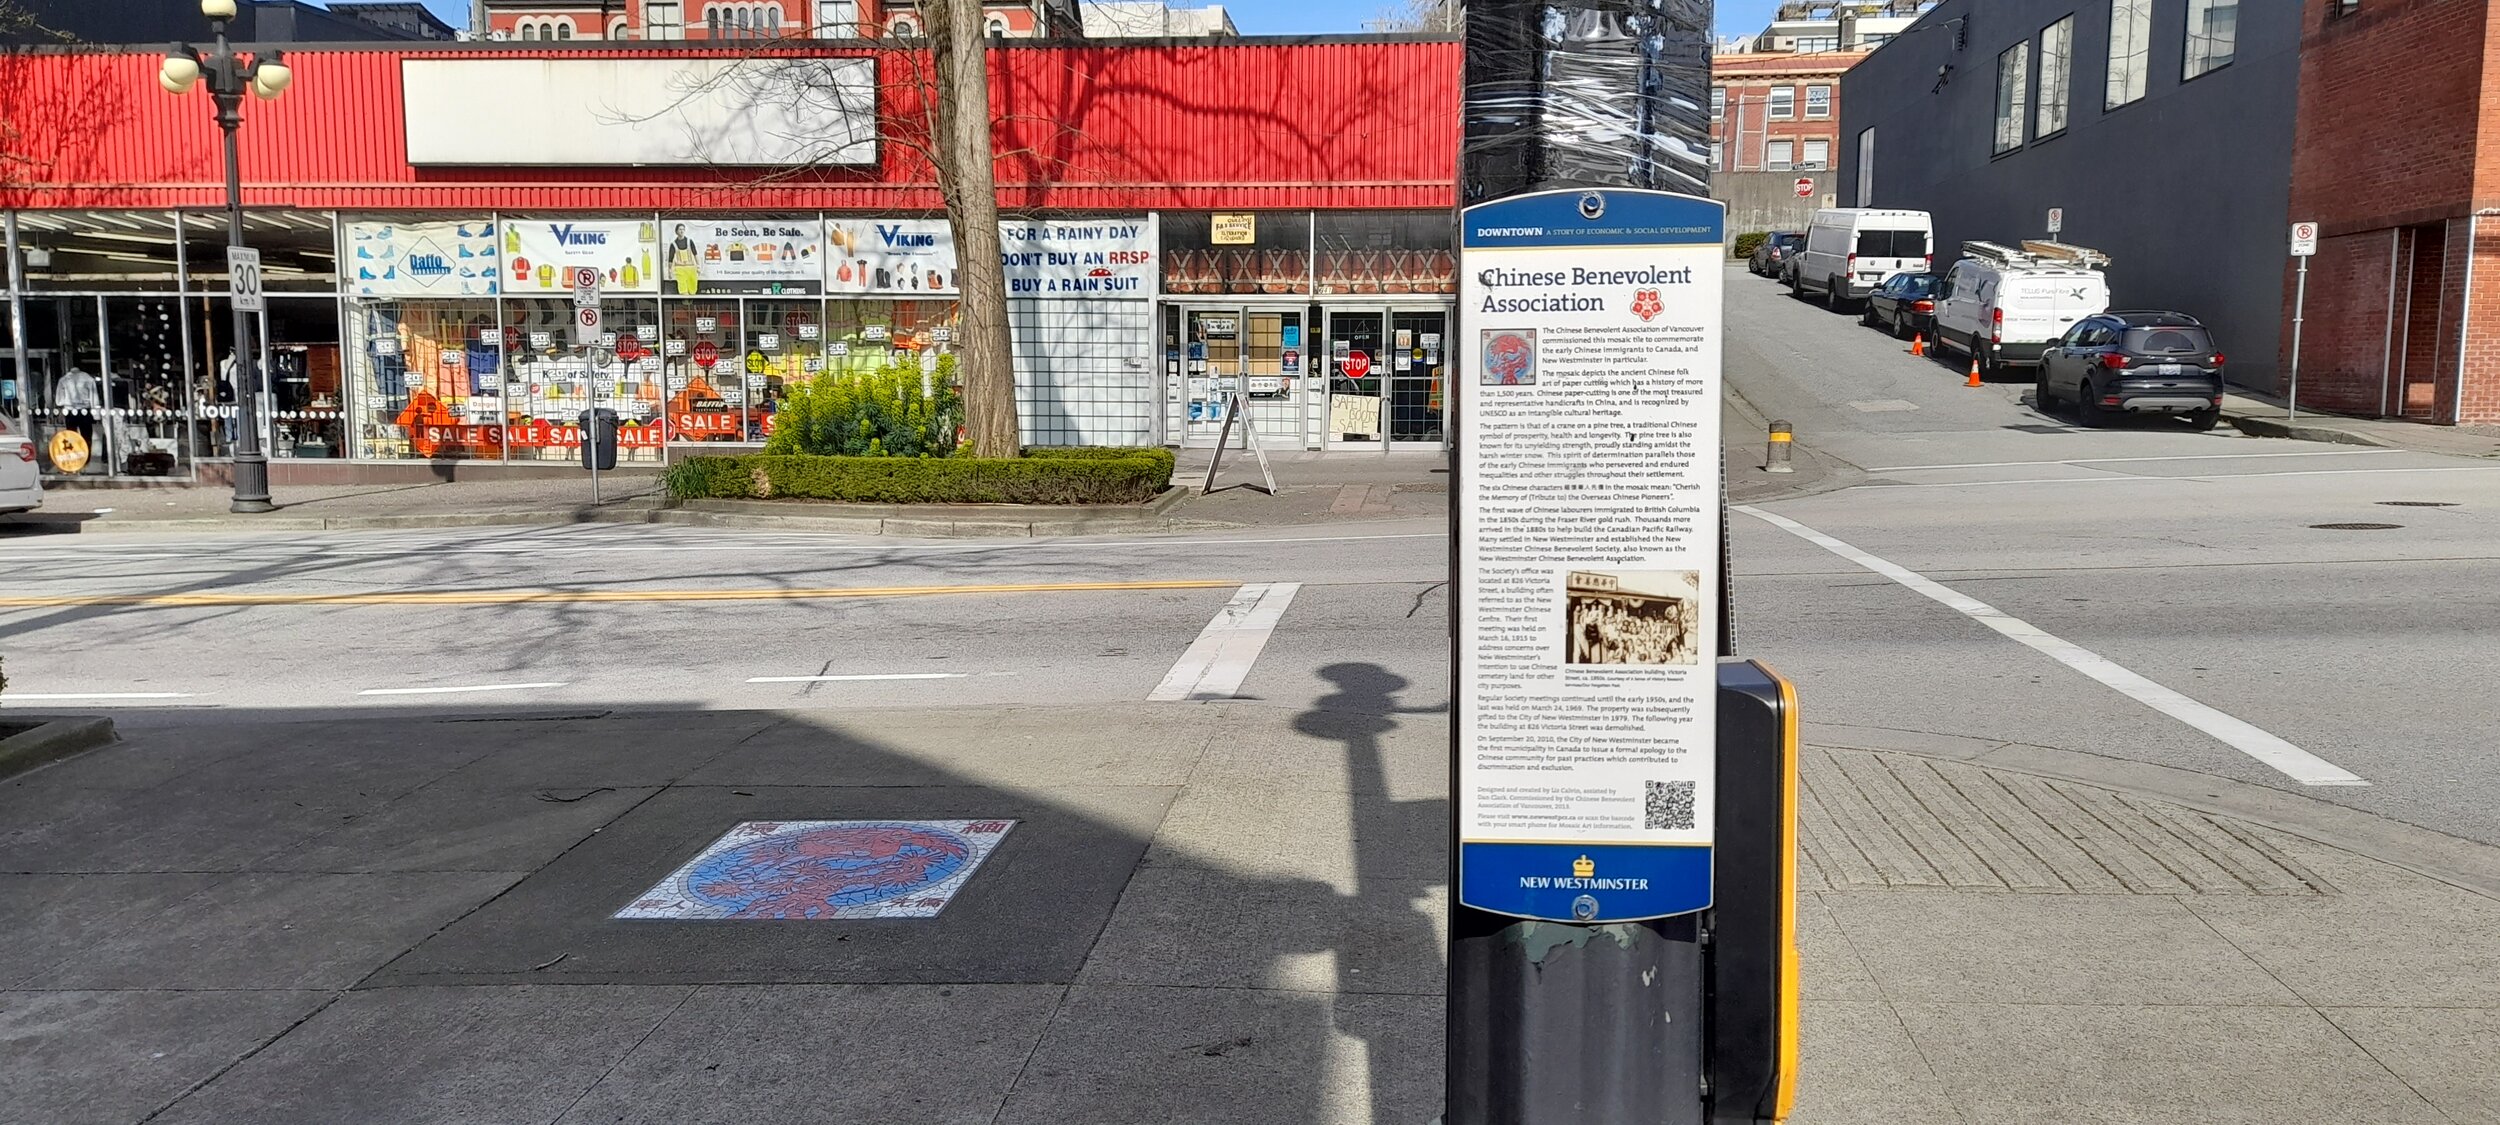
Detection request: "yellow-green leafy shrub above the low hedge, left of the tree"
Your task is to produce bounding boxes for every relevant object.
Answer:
[765,355,963,458]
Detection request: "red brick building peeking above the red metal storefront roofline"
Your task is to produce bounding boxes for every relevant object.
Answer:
[483,0,1083,40]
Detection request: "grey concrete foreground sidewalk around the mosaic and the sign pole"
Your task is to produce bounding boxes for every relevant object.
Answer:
[0,700,2500,1125]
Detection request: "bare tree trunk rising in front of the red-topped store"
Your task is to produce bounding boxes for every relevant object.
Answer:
[923,0,1023,458]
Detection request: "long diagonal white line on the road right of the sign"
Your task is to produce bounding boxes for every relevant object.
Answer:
[1738,505,2370,785]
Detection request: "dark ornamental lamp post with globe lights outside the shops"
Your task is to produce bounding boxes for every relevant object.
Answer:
[158,0,295,513]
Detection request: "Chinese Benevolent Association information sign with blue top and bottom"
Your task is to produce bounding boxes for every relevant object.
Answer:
[1450,190,1725,923]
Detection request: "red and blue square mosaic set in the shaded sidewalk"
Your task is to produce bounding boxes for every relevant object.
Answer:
[615,820,1015,920]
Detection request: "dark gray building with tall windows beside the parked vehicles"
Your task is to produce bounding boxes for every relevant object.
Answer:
[1835,0,2303,388]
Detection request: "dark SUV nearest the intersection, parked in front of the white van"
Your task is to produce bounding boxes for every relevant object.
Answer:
[2033,313,2223,430]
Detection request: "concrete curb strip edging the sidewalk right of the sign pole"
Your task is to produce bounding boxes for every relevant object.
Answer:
[1800,723,2500,900]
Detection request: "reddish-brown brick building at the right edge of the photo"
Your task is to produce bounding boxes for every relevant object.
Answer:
[2283,0,2500,423]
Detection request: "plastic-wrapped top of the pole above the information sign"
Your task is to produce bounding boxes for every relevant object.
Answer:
[1460,0,1713,203]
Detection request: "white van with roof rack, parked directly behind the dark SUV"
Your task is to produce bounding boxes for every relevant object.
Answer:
[1935,243,2110,375]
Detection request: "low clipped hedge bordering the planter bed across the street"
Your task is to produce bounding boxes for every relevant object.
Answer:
[665,448,1173,505]
